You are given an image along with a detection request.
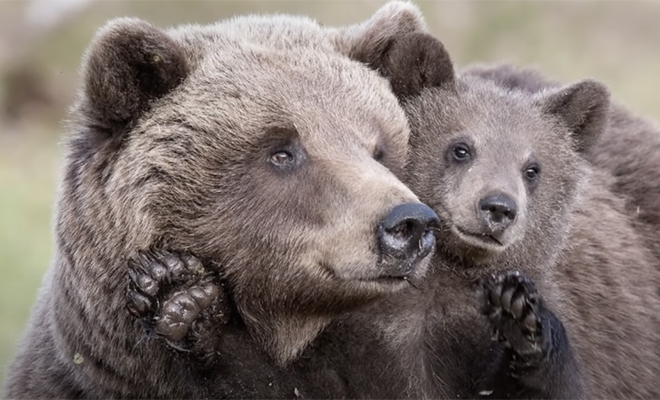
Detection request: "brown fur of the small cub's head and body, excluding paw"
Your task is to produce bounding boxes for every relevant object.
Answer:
[365,34,660,398]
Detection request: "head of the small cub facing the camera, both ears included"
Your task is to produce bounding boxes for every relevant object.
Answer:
[348,32,609,274]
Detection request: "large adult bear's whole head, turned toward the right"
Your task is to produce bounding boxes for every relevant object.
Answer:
[56,11,437,362]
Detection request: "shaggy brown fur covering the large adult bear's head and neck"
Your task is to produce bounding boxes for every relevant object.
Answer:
[5,5,444,398]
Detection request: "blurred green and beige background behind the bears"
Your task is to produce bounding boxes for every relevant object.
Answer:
[0,0,660,388]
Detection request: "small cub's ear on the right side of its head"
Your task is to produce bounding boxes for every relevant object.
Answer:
[537,80,610,153]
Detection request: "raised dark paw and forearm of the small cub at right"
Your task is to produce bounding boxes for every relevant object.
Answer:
[480,271,585,399]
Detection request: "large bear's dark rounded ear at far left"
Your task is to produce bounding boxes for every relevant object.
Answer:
[82,18,188,130]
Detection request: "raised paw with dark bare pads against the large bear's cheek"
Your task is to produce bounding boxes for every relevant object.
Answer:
[127,250,224,342]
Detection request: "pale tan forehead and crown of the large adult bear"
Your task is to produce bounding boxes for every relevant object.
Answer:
[137,16,408,157]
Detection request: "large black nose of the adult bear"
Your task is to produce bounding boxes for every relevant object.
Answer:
[378,203,440,277]
